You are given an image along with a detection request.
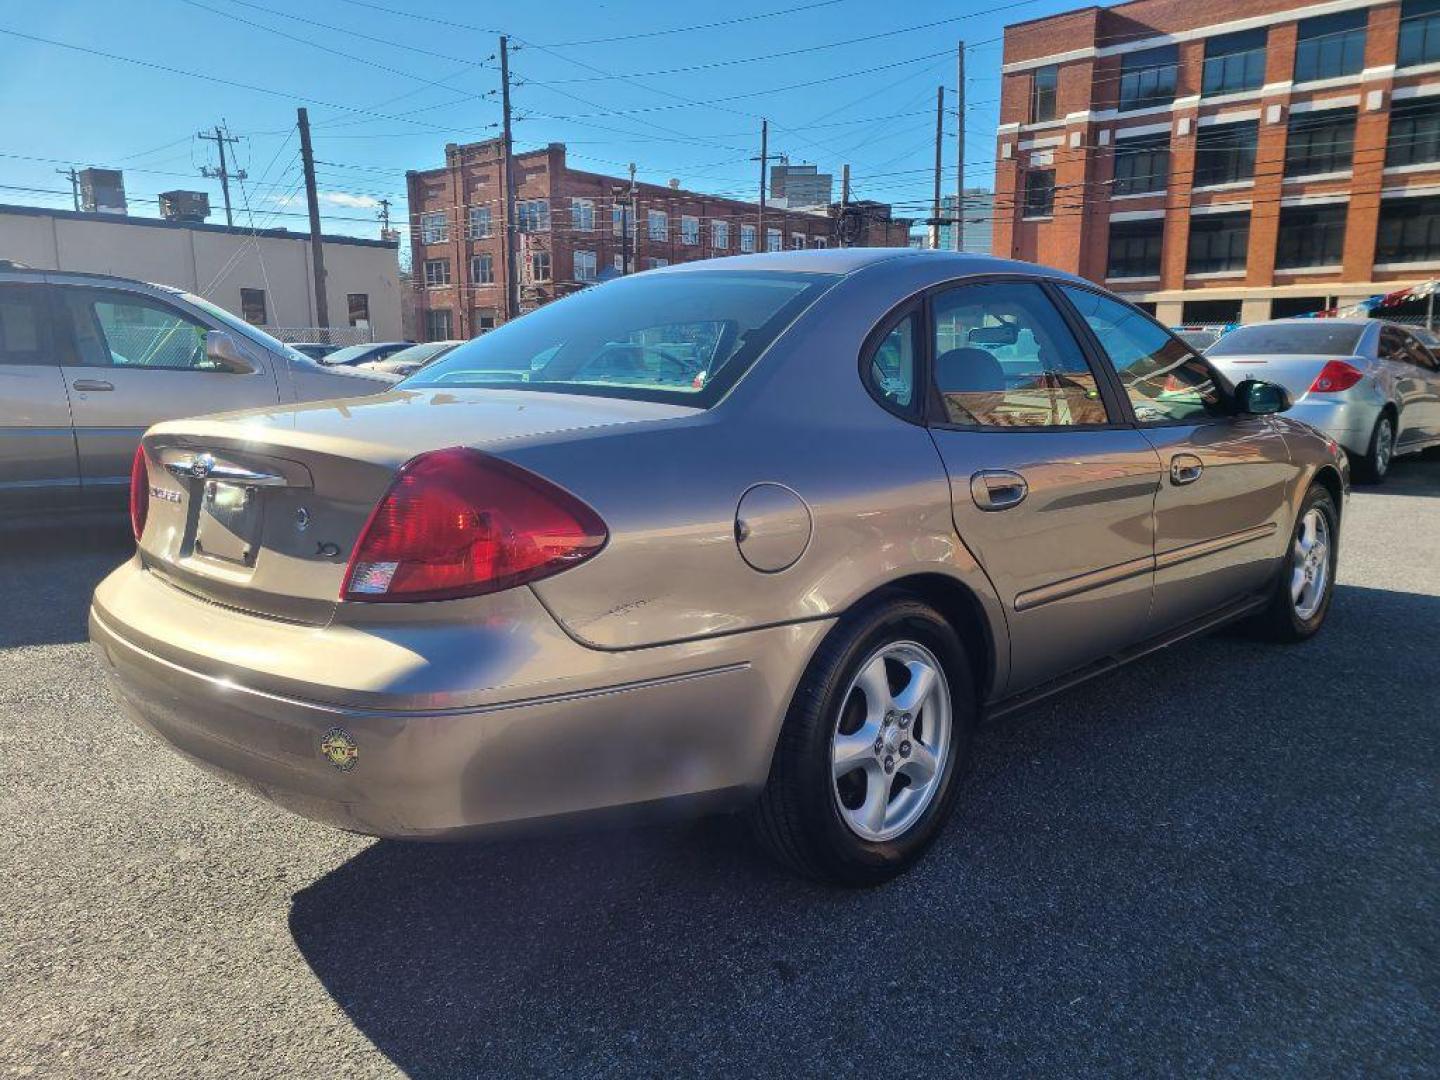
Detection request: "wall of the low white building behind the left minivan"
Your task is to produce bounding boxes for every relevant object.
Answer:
[0,207,402,340]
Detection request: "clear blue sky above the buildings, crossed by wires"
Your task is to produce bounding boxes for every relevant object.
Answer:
[0,0,1076,247]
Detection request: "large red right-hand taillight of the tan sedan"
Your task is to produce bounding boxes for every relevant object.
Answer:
[340,446,609,602]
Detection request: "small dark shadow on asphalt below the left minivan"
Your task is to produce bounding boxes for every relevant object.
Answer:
[0,514,135,648]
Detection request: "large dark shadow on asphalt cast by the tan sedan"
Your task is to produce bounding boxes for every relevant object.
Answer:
[289,586,1440,1080]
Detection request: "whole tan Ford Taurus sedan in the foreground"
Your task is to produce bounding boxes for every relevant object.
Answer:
[91,249,1349,884]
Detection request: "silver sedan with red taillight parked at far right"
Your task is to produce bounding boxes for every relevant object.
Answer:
[1205,318,1440,484]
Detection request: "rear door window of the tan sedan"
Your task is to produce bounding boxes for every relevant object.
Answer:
[933,282,1110,428]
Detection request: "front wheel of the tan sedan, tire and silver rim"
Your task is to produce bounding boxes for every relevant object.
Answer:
[1251,484,1341,642]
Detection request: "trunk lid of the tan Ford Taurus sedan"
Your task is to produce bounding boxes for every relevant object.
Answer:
[140,389,696,625]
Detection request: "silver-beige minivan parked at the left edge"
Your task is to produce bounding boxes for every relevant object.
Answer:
[0,268,395,508]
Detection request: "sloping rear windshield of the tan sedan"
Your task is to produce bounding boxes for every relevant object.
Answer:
[405,271,838,405]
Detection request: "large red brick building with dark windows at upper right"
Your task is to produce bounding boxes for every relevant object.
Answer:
[995,0,1440,323]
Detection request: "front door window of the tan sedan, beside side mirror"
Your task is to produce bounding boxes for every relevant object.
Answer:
[1061,285,1230,423]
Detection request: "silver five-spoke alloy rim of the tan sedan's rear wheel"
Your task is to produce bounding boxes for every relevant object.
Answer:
[831,641,952,841]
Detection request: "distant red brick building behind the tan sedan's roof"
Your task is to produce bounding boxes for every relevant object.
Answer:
[406,140,910,340]
